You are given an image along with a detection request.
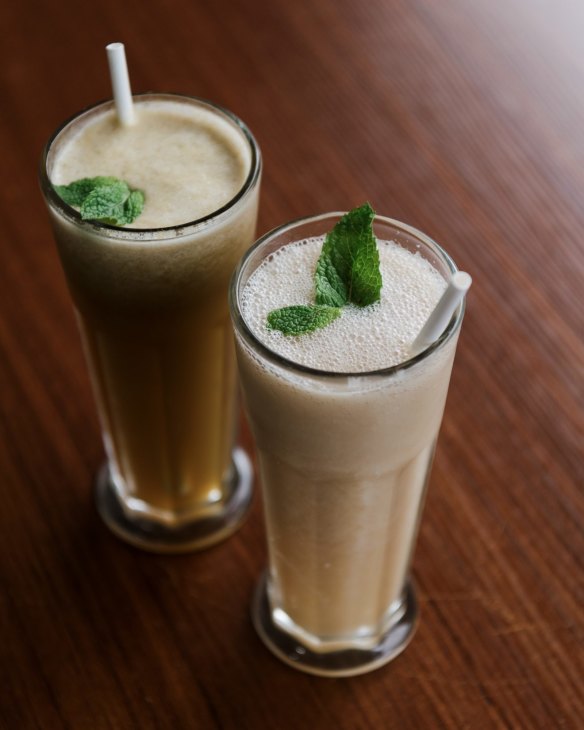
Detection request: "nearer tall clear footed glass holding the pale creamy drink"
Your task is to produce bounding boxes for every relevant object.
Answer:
[230,214,463,676]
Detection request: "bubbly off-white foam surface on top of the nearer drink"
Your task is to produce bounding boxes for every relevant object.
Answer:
[241,237,446,373]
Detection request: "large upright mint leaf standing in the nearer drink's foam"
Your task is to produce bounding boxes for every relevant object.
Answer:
[315,203,381,307]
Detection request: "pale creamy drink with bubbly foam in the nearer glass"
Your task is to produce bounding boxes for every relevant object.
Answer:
[232,215,461,675]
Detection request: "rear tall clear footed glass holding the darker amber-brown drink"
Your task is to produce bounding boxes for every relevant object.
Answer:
[40,94,261,552]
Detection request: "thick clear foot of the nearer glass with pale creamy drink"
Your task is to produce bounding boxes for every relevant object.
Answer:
[252,574,418,677]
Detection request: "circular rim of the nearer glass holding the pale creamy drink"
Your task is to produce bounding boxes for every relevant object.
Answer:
[229,211,465,379]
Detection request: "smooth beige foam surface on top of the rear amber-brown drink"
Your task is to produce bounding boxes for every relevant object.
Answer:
[51,100,250,228]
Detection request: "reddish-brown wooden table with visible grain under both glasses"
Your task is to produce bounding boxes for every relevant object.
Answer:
[0,0,584,730]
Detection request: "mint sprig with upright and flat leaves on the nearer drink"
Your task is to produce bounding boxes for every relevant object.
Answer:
[267,203,382,335]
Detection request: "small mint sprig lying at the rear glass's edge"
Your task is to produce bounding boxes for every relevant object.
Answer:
[54,176,145,226]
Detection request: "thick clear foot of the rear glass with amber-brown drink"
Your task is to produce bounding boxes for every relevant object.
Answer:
[95,449,253,553]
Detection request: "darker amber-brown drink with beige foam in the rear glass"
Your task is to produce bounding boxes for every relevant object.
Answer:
[43,95,260,550]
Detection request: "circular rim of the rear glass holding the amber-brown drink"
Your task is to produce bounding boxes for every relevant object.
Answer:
[39,91,262,241]
